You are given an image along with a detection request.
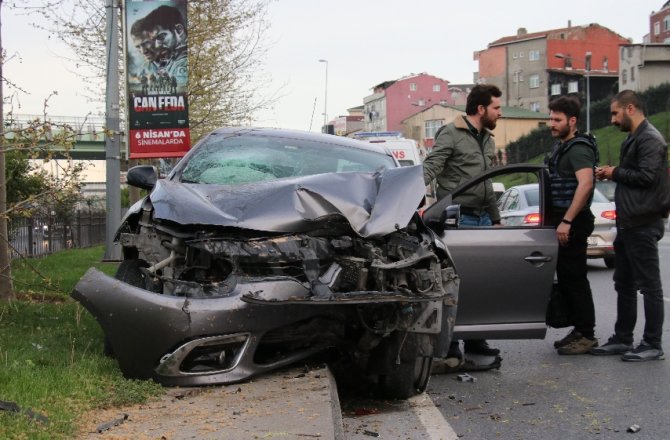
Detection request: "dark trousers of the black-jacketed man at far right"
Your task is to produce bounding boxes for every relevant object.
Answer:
[614,219,665,349]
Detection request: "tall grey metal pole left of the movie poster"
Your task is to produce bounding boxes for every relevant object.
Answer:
[103,0,121,261]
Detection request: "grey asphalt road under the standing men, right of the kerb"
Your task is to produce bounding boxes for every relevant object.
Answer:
[342,234,670,440]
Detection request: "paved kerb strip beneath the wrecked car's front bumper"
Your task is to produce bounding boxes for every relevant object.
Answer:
[79,366,344,440]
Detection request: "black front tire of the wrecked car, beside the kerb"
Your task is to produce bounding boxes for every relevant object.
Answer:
[379,331,433,399]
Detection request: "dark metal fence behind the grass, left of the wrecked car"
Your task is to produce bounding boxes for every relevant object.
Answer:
[9,211,106,258]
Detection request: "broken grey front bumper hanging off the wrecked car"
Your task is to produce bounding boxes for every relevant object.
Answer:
[72,268,457,386]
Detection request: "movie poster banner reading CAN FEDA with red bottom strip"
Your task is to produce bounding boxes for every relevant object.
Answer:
[124,0,190,159]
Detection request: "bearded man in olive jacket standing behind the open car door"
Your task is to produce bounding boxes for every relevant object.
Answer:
[423,84,502,372]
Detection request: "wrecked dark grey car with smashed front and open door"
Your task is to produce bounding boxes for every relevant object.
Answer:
[73,128,556,397]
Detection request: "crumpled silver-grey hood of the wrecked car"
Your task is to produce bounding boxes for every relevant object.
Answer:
[149,165,425,237]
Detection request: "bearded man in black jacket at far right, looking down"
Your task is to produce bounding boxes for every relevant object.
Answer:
[591,90,670,361]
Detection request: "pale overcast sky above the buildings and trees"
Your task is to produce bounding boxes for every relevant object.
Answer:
[2,0,666,131]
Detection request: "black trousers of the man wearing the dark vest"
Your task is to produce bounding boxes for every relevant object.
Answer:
[552,208,596,338]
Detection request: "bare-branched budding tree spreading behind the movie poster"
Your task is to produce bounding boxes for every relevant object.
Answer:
[26,0,277,141]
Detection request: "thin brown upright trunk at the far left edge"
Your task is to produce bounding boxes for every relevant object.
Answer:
[0,0,16,301]
